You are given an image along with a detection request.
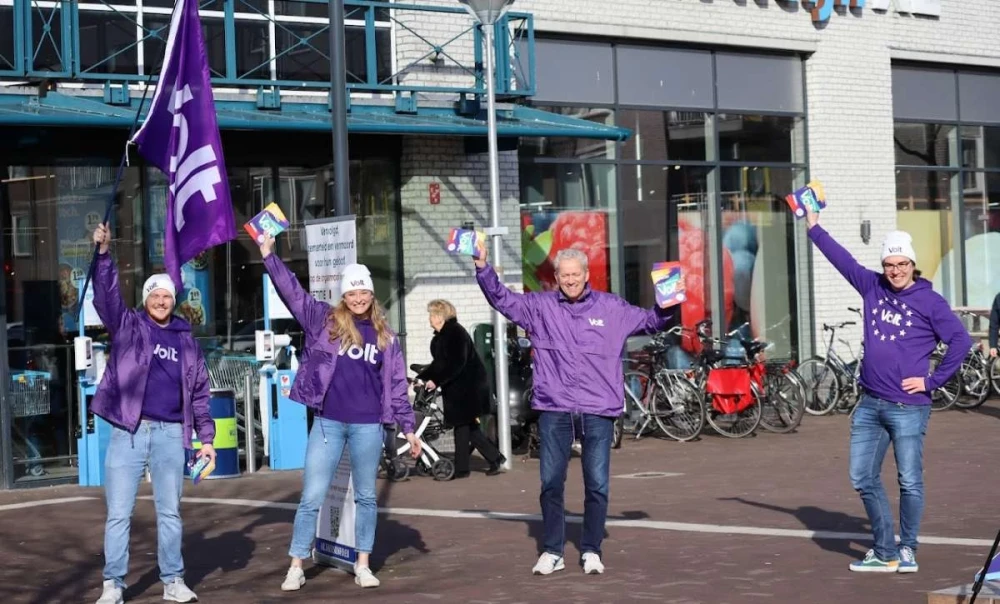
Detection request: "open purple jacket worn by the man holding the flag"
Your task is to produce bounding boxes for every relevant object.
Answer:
[90,254,215,448]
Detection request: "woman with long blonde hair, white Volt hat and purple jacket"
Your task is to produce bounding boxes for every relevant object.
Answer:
[260,236,420,591]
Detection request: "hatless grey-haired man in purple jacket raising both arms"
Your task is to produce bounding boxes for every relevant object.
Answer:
[475,249,672,575]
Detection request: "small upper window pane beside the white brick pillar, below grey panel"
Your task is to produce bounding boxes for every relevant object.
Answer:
[714,113,805,163]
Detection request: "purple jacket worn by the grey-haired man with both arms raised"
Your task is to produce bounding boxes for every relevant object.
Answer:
[476,265,673,417]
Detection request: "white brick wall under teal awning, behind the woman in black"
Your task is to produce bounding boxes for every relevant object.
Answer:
[401,137,521,364]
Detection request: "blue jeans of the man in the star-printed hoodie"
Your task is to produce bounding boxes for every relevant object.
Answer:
[851,394,931,561]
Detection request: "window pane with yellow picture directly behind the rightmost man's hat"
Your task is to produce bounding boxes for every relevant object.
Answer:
[896,169,962,305]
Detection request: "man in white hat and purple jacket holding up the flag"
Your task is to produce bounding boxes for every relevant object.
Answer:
[90,224,215,604]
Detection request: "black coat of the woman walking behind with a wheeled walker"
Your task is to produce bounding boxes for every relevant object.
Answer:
[417,319,490,426]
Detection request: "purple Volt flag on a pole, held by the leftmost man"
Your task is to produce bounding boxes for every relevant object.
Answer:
[132,0,236,292]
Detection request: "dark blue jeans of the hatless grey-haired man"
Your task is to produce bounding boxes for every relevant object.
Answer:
[538,411,614,556]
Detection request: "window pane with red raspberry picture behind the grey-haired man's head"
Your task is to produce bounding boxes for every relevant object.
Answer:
[520,164,617,291]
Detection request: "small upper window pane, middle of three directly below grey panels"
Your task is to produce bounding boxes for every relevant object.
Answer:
[618,109,714,161]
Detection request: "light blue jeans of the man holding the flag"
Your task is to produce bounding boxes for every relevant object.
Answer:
[104,420,190,589]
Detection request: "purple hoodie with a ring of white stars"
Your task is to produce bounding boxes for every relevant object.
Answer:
[809,225,972,405]
